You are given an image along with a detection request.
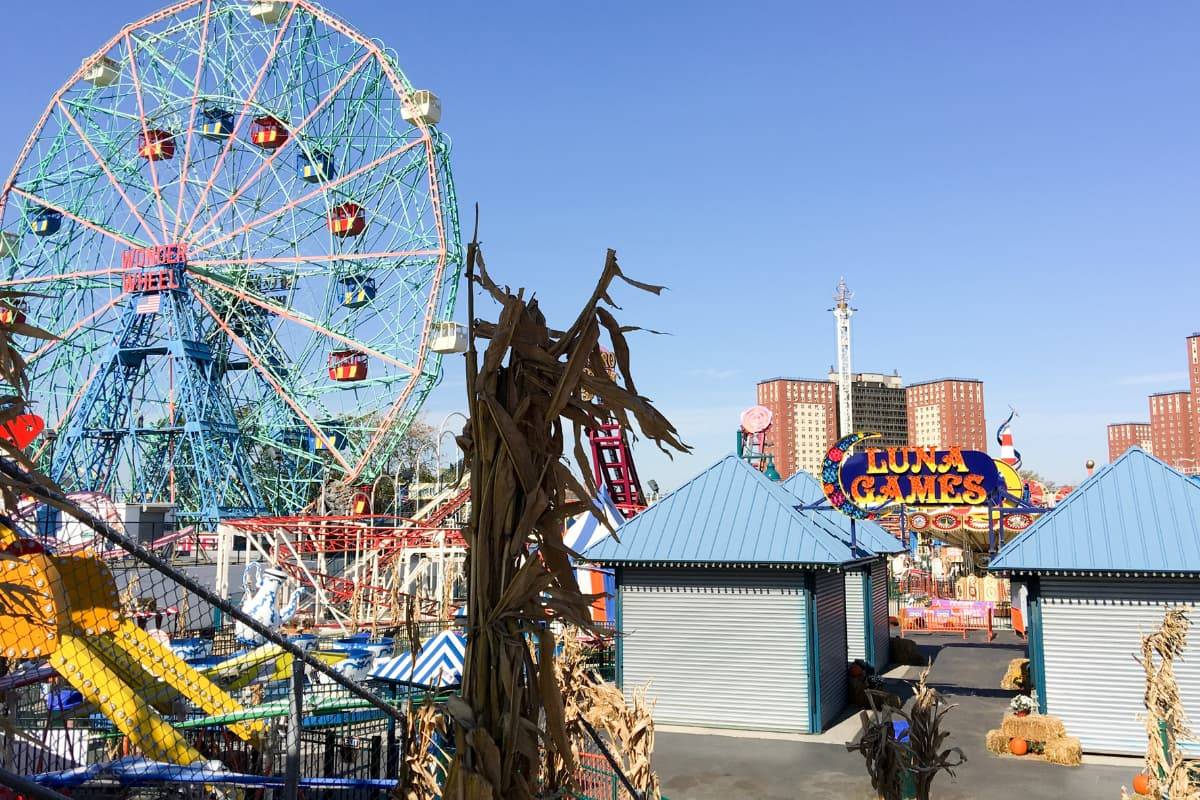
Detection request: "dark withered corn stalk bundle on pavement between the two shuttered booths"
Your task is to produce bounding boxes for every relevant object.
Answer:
[846,667,967,800]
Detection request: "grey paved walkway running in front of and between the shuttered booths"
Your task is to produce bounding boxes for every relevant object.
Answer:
[654,633,1140,800]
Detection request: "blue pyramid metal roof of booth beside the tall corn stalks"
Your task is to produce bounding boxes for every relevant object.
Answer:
[586,456,864,566]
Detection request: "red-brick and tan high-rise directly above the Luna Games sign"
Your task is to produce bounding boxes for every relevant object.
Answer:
[905,378,988,452]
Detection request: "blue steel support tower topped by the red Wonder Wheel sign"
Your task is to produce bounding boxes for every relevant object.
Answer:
[50,247,266,529]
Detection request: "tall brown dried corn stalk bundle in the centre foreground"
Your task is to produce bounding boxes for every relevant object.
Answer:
[445,242,688,800]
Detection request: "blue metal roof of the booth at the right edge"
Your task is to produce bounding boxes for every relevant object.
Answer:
[989,447,1200,573]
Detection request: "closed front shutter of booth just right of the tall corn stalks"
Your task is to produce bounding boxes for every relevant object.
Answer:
[620,569,816,732]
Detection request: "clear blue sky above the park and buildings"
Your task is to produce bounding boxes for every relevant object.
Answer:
[0,0,1200,488]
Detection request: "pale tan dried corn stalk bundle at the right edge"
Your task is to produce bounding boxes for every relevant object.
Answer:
[1121,608,1200,800]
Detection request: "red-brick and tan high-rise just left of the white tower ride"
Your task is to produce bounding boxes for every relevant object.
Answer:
[758,378,838,477]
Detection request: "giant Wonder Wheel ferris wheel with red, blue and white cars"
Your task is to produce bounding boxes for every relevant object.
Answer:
[0,0,461,532]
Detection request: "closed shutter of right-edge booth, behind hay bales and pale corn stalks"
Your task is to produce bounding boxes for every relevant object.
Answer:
[1040,578,1200,756]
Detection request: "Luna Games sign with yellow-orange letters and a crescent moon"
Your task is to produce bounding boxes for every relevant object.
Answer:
[821,433,1004,518]
